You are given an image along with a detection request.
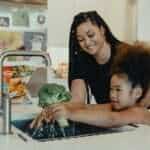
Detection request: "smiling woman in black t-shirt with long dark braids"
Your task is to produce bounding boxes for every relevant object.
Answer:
[69,11,121,104]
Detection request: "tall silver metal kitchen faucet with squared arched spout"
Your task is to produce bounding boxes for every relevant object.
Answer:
[0,50,51,134]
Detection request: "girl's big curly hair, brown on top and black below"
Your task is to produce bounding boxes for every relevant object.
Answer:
[111,45,150,102]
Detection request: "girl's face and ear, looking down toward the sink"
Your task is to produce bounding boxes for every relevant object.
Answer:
[110,74,142,110]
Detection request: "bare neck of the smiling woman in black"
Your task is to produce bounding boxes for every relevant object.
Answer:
[94,42,111,64]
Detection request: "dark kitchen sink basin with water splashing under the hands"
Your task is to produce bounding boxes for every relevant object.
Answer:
[12,119,136,141]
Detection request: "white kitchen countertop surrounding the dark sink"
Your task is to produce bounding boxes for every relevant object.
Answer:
[0,101,150,150]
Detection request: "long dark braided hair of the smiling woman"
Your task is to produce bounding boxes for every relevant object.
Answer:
[69,11,119,85]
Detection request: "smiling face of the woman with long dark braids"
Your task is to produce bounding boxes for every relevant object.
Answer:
[76,21,105,55]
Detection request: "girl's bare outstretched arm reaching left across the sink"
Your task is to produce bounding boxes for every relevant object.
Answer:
[67,107,150,127]
